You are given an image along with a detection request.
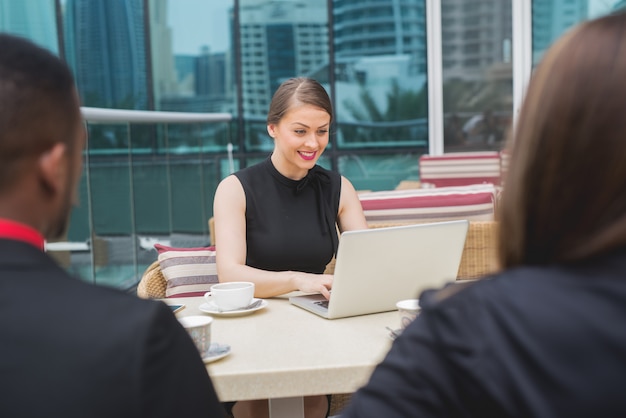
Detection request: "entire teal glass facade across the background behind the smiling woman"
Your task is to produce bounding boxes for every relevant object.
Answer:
[0,0,626,289]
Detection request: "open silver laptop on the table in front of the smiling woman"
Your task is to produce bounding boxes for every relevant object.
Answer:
[289,220,469,319]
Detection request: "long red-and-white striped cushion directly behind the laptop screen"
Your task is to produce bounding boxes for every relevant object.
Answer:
[359,184,498,226]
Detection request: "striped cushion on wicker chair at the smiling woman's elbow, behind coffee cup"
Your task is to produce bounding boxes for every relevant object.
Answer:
[154,244,218,298]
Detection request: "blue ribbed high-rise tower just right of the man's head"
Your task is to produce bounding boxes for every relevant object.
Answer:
[65,0,152,109]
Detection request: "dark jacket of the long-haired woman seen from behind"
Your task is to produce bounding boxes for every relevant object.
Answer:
[342,250,626,418]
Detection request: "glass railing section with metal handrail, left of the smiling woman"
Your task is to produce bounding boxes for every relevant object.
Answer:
[47,107,236,291]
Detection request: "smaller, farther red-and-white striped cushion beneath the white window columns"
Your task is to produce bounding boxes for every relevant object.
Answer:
[419,151,501,187]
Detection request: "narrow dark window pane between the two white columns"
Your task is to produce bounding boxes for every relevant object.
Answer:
[441,0,513,152]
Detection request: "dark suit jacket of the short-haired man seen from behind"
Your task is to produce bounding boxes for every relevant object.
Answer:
[0,239,224,418]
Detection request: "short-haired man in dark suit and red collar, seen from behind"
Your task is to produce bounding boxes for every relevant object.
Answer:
[0,34,224,418]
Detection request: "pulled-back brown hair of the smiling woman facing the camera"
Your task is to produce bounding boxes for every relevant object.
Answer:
[267,77,333,124]
